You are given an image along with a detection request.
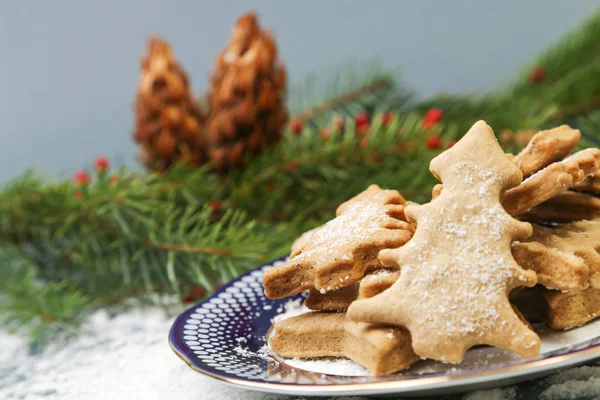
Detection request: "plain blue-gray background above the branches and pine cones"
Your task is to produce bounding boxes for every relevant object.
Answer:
[0,0,598,181]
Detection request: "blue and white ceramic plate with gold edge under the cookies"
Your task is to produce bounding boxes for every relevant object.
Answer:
[169,259,600,396]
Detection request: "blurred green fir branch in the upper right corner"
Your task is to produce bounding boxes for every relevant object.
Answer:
[417,11,600,134]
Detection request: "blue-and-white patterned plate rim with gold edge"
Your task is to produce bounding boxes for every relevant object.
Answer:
[169,257,600,396]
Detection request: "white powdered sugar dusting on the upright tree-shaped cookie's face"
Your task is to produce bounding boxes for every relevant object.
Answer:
[400,163,532,337]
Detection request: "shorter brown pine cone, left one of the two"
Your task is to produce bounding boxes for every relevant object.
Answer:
[134,38,207,172]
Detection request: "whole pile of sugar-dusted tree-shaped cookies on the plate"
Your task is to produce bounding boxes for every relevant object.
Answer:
[263,121,600,375]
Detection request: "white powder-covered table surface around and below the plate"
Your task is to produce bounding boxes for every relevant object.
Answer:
[0,309,600,400]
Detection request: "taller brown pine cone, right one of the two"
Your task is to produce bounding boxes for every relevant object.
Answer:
[207,13,288,171]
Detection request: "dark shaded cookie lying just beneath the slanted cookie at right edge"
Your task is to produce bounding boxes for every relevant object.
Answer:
[519,190,600,223]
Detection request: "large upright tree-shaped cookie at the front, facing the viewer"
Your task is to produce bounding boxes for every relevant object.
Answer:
[348,121,540,363]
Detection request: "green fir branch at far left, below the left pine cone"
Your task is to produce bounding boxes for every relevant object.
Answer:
[0,166,276,310]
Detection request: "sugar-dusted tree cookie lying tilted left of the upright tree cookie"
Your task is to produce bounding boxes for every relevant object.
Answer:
[263,185,413,299]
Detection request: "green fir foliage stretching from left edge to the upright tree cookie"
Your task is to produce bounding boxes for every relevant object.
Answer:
[0,114,458,344]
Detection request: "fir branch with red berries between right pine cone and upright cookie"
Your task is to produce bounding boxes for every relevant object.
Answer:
[226,114,457,222]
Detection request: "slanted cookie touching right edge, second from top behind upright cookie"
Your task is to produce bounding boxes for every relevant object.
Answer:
[502,149,600,215]
